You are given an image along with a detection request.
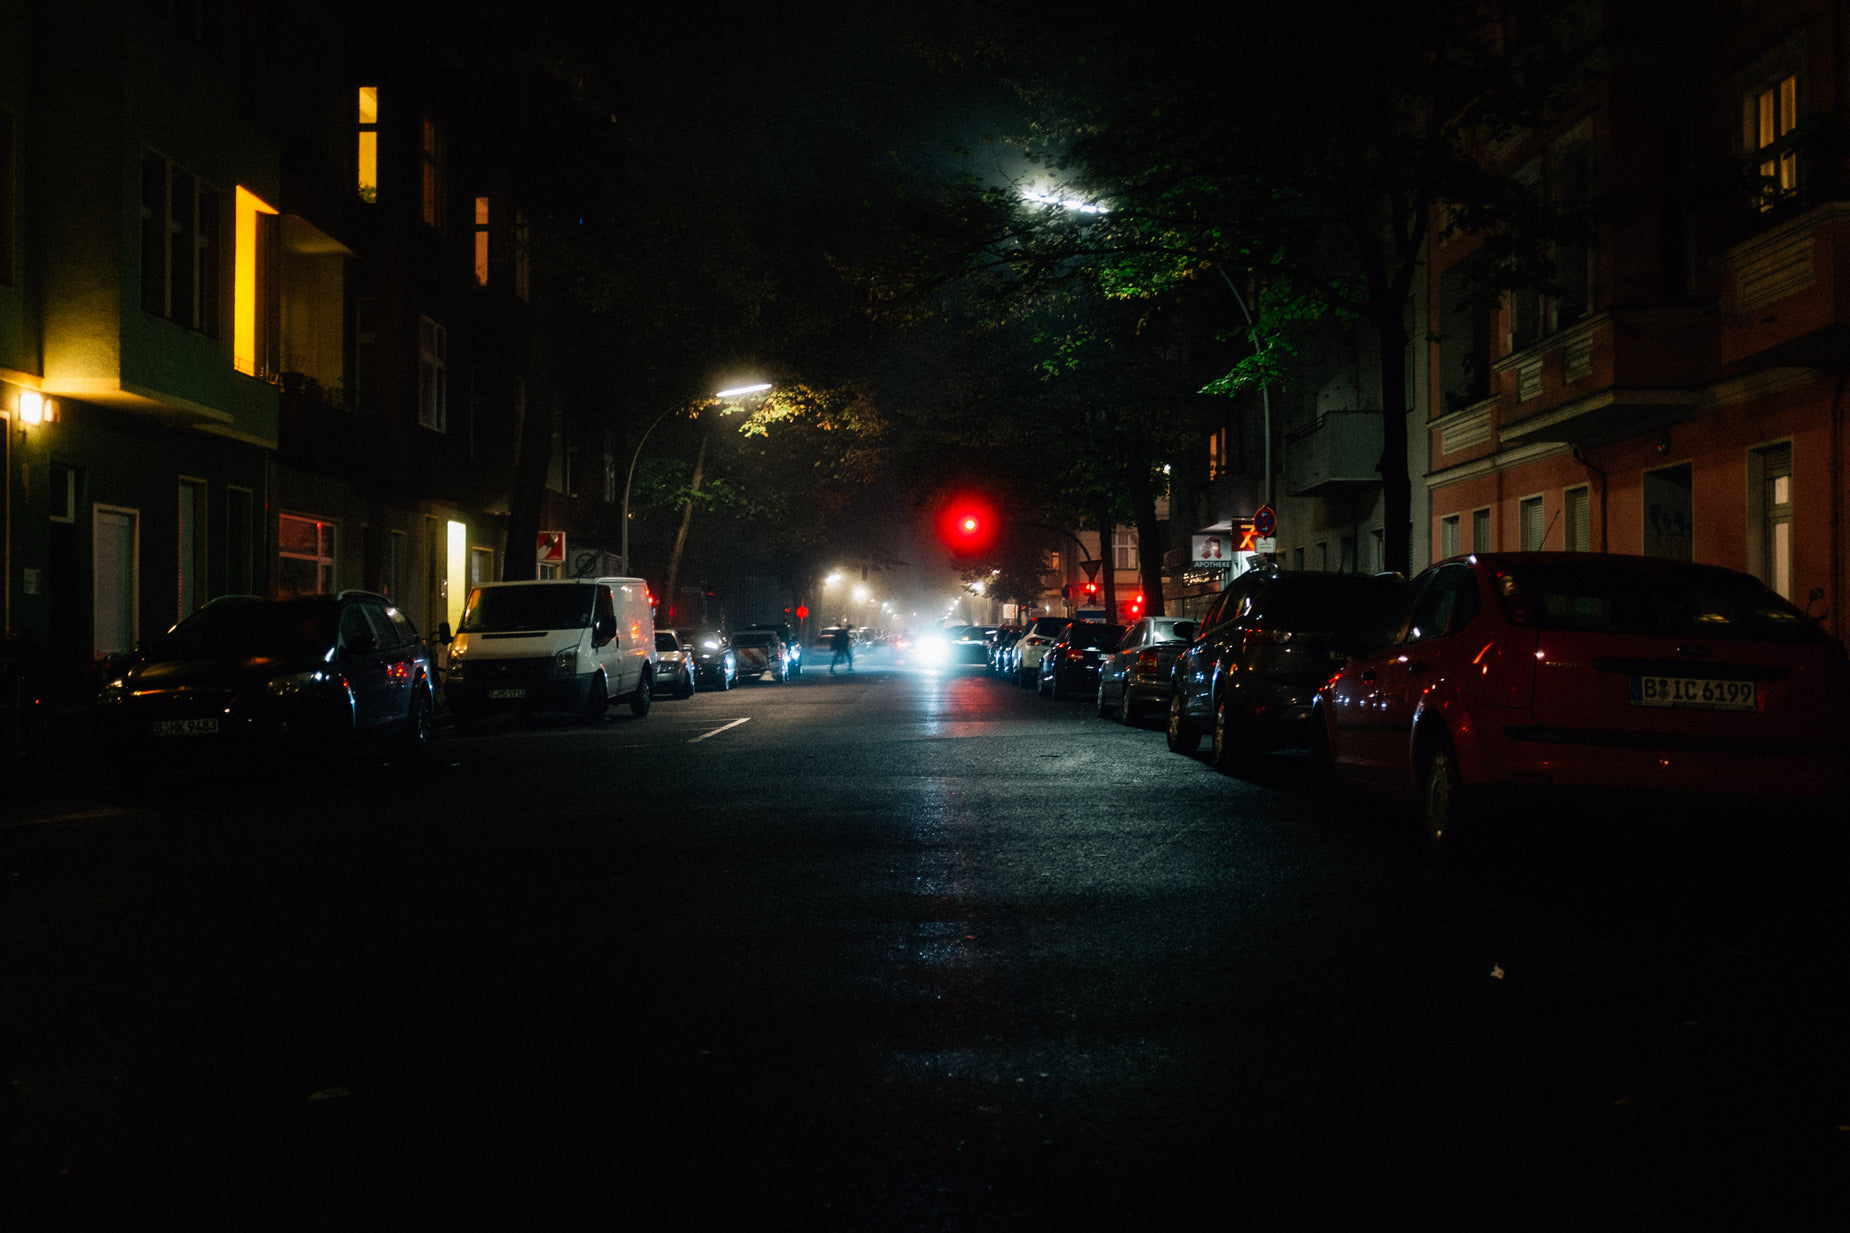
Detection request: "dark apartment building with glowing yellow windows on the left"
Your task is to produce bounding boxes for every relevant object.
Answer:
[0,0,620,698]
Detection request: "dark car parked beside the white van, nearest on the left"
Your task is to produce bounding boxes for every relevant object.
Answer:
[96,591,433,778]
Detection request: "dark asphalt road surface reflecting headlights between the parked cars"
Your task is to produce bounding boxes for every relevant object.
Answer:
[0,657,1850,1229]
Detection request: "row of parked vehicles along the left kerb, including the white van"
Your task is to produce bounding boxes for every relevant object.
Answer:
[96,578,801,781]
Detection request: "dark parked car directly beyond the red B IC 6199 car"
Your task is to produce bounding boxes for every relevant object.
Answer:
[1167,570,1402,770]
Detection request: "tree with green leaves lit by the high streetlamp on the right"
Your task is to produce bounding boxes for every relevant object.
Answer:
[877,0,1578,570]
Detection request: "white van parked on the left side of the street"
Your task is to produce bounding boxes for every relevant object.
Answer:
[444,578,655,724]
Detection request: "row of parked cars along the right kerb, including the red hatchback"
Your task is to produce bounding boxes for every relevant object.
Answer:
[1021,552,1850,844]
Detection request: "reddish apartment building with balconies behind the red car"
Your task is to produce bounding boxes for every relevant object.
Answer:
[1426,2,1850,637]
